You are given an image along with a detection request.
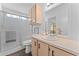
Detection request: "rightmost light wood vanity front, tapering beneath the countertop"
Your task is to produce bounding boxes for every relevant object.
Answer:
[49,46,73,56]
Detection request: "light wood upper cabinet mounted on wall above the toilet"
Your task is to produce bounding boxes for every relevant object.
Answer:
[28,3,42,24]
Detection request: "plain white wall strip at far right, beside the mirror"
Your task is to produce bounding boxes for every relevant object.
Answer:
[68,3,79,40]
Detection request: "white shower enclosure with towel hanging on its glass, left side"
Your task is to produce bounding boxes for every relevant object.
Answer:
[0,7,29,55]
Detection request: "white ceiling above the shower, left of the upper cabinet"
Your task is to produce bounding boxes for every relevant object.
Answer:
[2,3,34,14]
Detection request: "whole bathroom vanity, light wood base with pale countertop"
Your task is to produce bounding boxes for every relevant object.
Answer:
[32,34,79,56]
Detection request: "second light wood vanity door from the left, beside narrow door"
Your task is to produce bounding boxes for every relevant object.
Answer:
[38,41,48,56]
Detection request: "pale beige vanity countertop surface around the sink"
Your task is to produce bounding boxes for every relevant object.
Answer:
[32,34,79,56]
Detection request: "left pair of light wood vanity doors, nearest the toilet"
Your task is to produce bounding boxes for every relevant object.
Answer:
[32,39,48,56]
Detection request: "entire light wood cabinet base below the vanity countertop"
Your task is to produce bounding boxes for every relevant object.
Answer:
[32,39,74,56]
